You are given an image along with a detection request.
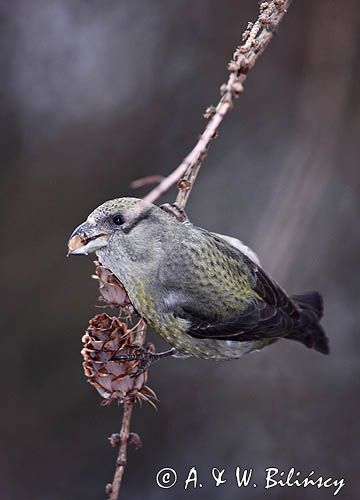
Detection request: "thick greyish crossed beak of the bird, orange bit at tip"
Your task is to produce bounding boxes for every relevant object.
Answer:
[68,221,110,255]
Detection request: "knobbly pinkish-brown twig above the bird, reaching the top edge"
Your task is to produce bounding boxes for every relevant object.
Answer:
[142,0,292,208]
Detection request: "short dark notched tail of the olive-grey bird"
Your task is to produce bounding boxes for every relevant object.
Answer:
[287,292,330,354]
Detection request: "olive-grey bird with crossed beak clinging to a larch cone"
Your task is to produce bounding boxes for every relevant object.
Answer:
[68,197,329,364]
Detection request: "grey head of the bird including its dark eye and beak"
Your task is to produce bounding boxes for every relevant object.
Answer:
[68,198,181,267]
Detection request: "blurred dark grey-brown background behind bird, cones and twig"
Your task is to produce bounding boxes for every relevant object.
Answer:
[0,0,360,500]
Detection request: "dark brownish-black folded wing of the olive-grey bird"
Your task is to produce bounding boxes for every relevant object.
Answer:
[170,229,299,340]
